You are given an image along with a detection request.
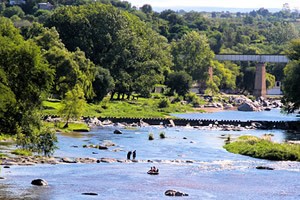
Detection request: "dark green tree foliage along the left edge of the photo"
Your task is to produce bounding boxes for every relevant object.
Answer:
[0,18,53,136]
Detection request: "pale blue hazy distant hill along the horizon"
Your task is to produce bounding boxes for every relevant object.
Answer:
[153,7,281,13]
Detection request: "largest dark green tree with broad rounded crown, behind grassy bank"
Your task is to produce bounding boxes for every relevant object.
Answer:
[47,3,172,99]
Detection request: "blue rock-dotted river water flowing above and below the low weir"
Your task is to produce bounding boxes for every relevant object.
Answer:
[0,111,300,200]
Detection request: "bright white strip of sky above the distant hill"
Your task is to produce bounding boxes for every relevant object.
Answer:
[126,0,300,10]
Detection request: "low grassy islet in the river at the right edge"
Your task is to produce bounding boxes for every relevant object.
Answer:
[224,136,300,161]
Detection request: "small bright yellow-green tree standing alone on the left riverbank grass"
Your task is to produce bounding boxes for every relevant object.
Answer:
[59,85,86,128]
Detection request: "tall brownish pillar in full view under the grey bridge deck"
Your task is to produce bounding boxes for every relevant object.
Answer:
[253,63,267,97]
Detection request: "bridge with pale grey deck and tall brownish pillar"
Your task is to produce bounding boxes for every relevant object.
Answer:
[215,54,289,97]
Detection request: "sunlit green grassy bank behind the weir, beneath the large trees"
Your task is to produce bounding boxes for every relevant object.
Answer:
[43,95,197,118]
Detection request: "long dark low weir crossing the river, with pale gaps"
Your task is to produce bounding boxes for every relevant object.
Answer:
[98,117,300,131]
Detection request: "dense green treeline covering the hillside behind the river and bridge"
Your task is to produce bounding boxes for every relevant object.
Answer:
[0,0,300,154]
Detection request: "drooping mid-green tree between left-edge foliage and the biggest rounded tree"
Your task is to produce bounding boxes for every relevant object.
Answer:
[23,23,97,100]
